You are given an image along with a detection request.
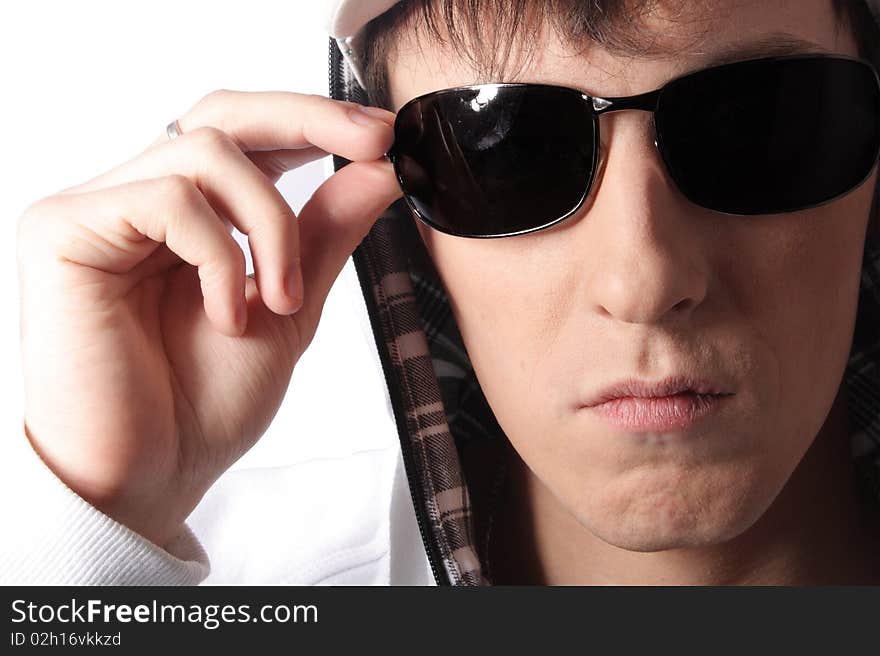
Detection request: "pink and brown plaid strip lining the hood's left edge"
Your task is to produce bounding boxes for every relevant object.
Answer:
[354,203,489,585]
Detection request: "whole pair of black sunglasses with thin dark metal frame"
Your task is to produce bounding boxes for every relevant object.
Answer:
[387,55,880,237]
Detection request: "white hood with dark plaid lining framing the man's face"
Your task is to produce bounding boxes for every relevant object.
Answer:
[325,0,880,585]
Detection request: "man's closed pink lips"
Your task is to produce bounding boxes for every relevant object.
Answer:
[581,376,733,432]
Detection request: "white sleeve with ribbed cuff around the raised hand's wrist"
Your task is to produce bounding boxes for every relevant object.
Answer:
[0,425,210,585]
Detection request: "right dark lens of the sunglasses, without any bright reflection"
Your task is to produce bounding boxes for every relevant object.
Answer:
[655,57,880,214]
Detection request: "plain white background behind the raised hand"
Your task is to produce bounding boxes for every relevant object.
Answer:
[0,0,392,464]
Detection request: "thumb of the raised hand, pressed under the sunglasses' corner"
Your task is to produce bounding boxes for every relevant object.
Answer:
[297,160,401,320]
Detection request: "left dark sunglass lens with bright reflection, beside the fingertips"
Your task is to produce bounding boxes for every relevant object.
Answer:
[393,84,596,236]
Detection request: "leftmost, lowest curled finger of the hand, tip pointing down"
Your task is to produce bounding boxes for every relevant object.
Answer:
[30,175,246,335]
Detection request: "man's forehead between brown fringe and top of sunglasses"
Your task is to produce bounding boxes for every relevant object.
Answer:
[388,0,857,111]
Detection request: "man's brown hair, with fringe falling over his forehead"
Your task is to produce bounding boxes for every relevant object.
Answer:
[361,0,880,110]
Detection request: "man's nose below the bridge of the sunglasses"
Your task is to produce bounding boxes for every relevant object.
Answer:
[581,112,711,323]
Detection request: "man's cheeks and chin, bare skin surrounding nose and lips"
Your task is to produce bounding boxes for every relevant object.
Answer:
[423,185,873,548]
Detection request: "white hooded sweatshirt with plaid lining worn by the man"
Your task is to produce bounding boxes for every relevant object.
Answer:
[0,0,880,585]
